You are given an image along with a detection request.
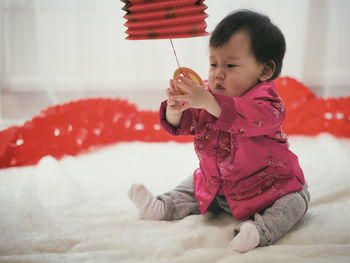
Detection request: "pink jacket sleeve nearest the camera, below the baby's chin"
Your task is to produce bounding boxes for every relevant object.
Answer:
[208,85,285,137]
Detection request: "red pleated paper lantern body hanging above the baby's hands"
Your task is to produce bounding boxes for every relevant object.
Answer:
[121,0,208,40]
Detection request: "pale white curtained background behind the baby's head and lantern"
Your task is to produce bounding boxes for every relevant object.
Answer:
[0,0,350,115]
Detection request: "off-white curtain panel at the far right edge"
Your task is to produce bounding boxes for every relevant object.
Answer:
[301,0,350,97]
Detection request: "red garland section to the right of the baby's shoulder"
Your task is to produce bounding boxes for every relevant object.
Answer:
[276,77,350,138]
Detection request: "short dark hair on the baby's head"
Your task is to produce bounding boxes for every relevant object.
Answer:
[209,9,286,80]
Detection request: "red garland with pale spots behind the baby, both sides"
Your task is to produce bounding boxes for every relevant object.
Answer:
[0,77,350,168]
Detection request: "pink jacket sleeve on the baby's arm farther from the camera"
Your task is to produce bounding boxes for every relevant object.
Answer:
[159,101,199,136]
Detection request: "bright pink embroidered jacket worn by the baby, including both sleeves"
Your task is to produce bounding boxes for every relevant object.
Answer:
[160,81,305,220]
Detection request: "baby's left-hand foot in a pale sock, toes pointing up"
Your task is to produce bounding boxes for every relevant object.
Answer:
[128,184,165,220]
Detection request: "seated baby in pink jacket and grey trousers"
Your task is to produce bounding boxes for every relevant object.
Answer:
[129,10,310,252]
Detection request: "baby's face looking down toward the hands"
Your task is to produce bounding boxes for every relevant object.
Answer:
[208,31,263,97]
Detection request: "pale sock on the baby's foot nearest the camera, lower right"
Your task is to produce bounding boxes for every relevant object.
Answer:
[228,223,260,253]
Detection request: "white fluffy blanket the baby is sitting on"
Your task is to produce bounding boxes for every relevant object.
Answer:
[0,134,350,263]
